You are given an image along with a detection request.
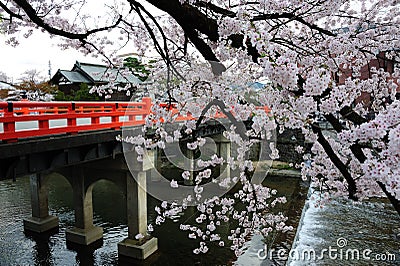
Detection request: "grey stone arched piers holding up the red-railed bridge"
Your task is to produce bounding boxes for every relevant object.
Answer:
[24,131,233,259]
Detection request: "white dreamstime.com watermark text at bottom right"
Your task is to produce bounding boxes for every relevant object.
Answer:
[257,238,396,262]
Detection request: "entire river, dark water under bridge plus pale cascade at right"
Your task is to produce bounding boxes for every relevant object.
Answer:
[0,172,400,266]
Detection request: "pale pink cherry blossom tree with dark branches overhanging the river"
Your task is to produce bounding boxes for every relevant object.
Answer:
[0,0,400,254]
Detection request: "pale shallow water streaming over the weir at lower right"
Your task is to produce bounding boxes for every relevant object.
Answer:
[287,193,400,266]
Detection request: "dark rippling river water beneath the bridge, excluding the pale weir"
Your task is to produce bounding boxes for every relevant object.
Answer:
[0,171,302,266]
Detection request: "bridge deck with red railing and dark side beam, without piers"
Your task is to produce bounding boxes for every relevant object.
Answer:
[0,98,268,179]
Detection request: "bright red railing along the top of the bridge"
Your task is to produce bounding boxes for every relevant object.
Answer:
[0,97,268,142]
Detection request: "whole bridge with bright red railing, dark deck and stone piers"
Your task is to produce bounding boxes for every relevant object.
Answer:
[0,98,276,259]
